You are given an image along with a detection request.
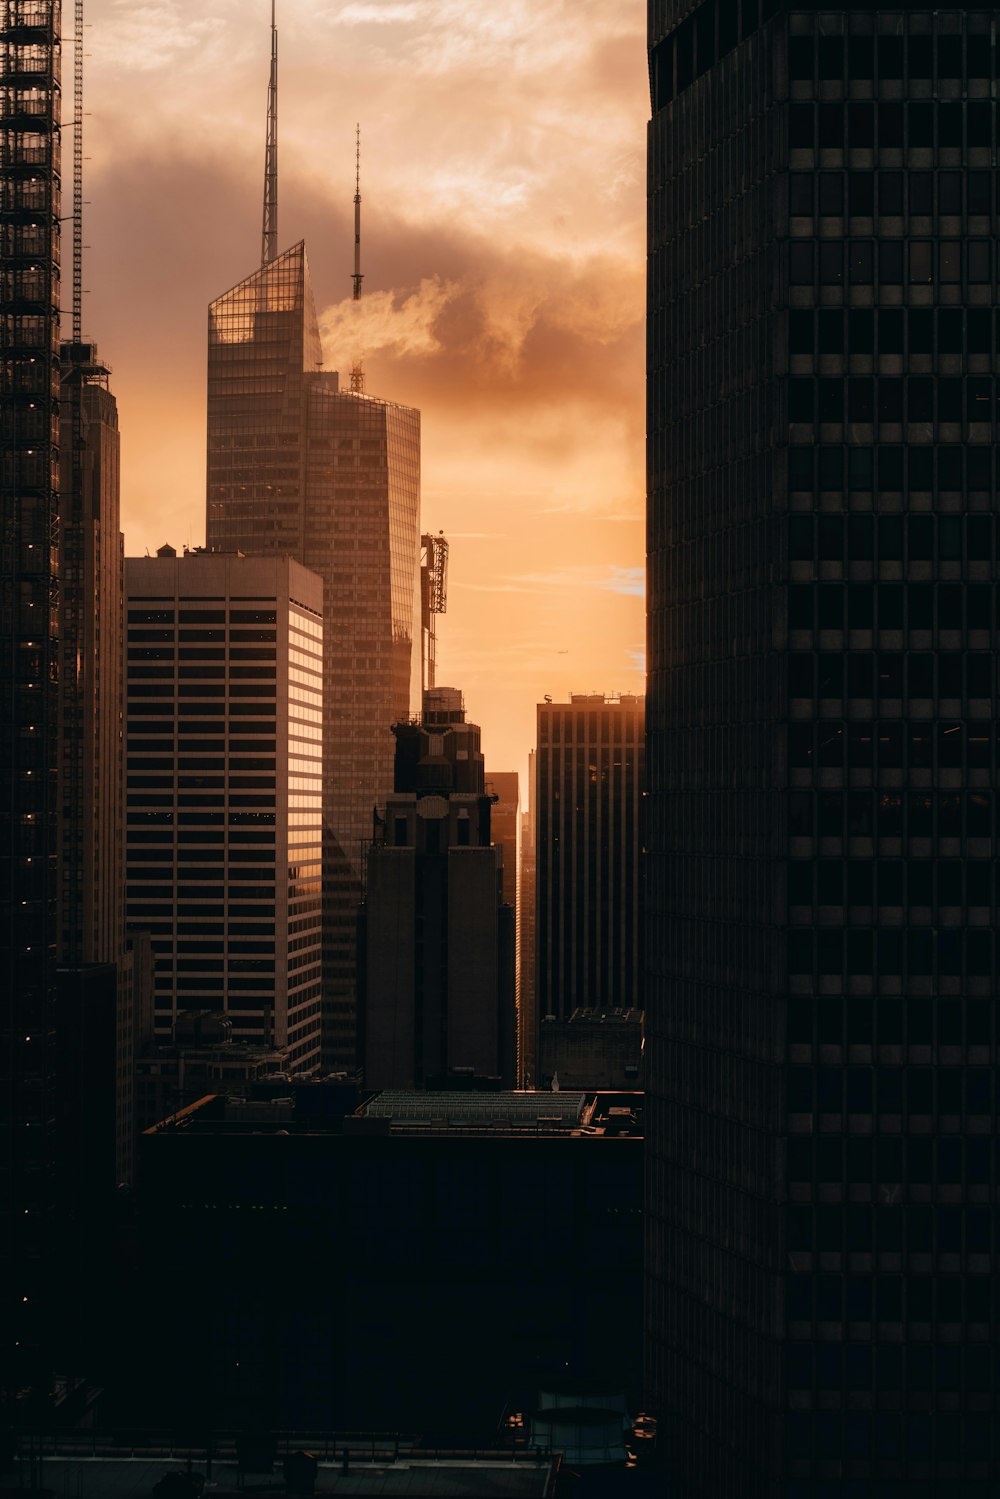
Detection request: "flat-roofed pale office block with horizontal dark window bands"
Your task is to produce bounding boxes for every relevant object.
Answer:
[124,547,324,1070]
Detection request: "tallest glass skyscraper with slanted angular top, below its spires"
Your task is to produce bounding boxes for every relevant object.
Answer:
[207,241,420,1067]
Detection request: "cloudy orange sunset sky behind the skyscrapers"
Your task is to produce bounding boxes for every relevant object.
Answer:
[80,0,648,797]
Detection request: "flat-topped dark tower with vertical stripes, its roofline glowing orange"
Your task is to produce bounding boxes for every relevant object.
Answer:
[534,694,645,1022]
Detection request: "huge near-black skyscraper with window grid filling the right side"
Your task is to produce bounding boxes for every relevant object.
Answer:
[646,0,1000,1499]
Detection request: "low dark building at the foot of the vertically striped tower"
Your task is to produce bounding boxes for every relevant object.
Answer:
[538,1010,643,1091]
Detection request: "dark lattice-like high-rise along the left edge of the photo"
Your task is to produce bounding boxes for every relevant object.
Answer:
[0,0,61,1391]
